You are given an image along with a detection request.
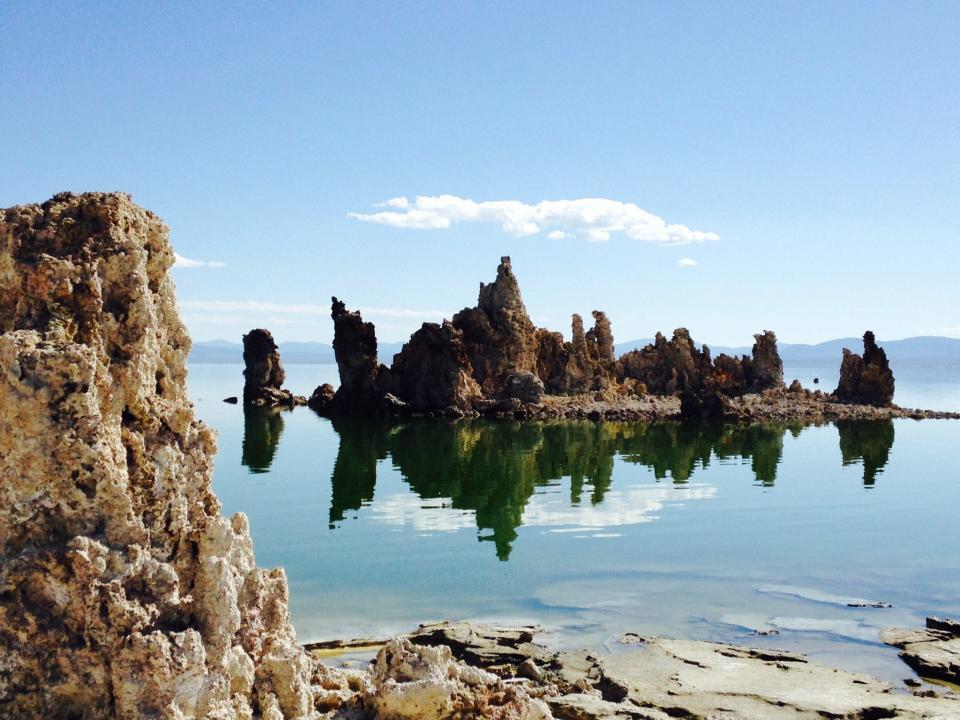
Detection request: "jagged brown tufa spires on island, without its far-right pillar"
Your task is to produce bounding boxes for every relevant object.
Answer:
[310,257,804,417]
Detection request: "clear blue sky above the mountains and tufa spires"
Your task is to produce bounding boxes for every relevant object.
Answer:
[0,2,960,345]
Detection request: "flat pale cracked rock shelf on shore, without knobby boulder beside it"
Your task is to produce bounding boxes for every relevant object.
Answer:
[378,623,960,720]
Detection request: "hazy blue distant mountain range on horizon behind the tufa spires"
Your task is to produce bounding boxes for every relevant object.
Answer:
[189,336,960,366]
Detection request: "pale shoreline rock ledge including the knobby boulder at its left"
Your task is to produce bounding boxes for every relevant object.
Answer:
[306,623,960,720]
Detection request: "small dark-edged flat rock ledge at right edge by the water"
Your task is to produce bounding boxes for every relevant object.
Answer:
[880,617,960,685]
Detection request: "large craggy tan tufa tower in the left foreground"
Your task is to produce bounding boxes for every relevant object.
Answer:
[0,193,314,720]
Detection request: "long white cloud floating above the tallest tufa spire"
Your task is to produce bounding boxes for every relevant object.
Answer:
[347,195,720,245]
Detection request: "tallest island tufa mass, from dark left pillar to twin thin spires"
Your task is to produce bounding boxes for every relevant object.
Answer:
[324,257,615,417]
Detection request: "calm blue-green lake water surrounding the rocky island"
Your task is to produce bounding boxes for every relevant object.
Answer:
[190,365,960,680]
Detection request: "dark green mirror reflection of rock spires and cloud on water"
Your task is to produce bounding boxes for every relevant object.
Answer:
[236,410,894,560]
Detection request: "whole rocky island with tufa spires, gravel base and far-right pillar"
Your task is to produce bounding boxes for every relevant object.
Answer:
[302,257,957,420]
